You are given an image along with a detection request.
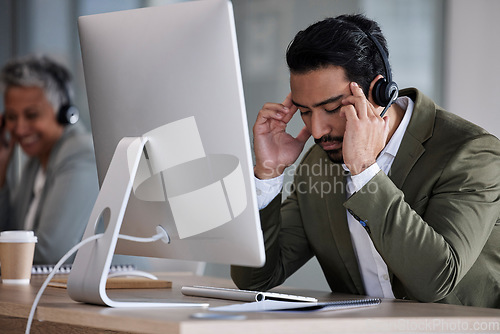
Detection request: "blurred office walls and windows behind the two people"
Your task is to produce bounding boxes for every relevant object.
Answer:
[0,0,500,289]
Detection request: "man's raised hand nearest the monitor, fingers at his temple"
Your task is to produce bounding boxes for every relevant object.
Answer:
[253,94,311,179]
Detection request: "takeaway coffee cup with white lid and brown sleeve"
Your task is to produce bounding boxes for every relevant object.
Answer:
[0,231,38,284]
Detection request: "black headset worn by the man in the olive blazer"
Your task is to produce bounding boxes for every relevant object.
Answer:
[360,29,398,117]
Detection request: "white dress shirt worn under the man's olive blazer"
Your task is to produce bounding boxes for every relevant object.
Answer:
[255,97,414,298]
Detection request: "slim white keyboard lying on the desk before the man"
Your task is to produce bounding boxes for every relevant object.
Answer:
[181,285,318,302]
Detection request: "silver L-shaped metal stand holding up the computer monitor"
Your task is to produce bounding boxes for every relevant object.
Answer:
[68,137,208,308]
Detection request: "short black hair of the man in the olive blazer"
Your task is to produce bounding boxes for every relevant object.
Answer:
[286,14,389,96]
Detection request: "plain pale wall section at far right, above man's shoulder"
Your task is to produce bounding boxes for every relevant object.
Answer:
[444,0,500,137]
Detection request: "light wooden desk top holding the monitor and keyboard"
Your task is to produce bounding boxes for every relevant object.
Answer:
[0,274,500,334]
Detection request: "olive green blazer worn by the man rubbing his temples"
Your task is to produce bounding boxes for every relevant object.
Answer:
[231,89,500,308]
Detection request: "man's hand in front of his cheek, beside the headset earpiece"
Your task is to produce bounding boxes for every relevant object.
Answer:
[341,82,389,175]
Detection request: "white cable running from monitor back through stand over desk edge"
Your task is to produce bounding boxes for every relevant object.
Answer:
[25,233,164,334]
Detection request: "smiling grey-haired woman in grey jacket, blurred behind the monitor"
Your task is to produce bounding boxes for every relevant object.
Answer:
[0,57,98,264]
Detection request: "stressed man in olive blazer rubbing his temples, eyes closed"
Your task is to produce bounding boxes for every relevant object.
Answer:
[231,15,500,308]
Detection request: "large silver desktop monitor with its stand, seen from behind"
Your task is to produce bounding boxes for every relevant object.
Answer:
[68,0,265,306]
